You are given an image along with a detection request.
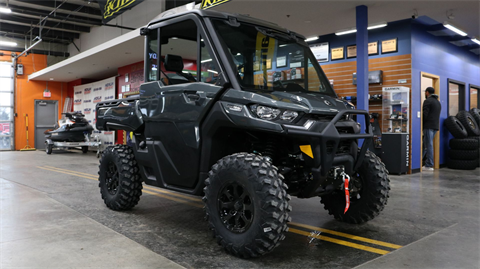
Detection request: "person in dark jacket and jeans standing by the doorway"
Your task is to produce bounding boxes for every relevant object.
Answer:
[423,87,442,171]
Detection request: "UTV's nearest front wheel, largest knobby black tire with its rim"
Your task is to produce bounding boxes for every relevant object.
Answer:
[203,153,292,258]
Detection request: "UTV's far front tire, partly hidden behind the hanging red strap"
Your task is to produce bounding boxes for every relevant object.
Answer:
[320,151,390,224]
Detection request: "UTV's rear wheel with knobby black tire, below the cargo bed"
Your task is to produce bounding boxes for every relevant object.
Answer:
[98,145,143,211]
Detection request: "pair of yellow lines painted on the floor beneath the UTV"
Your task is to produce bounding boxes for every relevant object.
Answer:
[37,163,402,255]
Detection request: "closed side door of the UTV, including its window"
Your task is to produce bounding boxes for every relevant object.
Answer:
[137,15,225,189]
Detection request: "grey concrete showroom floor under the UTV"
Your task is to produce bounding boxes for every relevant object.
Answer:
[0,151,480,268]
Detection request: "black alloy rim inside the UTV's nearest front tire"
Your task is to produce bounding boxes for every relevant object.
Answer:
[218,182,254,233]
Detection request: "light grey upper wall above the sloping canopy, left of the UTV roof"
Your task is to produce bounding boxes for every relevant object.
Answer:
[68,0,166,57]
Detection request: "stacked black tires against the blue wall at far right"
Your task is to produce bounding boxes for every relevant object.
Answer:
[445,108,480,170]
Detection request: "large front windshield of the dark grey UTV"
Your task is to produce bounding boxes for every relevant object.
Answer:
[213,19,336,96]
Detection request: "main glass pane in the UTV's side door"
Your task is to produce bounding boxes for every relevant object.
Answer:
[160,20,198,85]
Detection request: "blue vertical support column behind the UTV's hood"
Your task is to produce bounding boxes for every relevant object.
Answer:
[356,5,368,134]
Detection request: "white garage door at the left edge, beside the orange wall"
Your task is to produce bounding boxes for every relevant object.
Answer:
[0,62,14,150]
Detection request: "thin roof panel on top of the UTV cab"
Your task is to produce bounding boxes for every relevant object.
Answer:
[147,6,305,40]
